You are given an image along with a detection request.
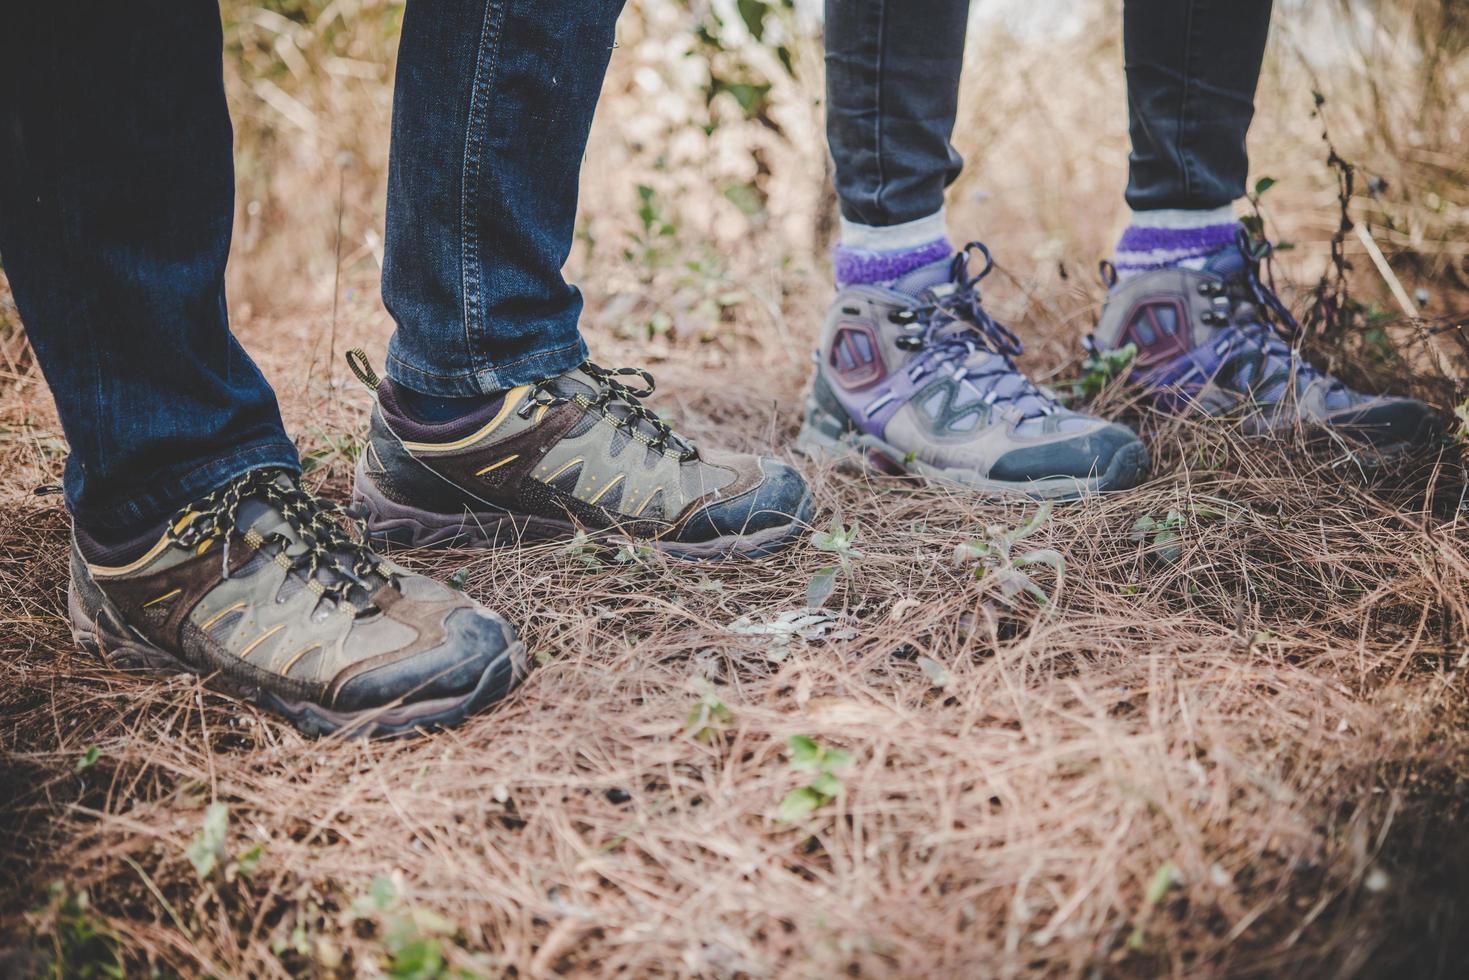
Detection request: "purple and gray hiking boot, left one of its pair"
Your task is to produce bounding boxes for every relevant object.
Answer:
[796,242,1147,500]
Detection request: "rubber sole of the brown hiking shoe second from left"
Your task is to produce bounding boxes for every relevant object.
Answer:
[353,463,815,561]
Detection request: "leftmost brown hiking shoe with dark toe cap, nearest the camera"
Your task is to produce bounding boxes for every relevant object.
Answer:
[69,470,524,735]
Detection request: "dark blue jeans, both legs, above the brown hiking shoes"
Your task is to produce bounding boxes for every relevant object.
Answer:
[0,0,621,536]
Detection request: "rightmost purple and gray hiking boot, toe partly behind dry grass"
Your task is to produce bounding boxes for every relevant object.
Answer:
[1091,229,1443,457]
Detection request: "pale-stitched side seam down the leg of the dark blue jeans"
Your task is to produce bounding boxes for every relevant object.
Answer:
[460,0,504,390]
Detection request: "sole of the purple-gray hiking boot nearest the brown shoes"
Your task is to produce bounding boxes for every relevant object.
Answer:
[796,407,1149,501]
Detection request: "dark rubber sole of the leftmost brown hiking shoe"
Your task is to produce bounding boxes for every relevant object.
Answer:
[66,583,527,738]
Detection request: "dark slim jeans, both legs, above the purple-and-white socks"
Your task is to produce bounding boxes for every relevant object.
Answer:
[826,0,1271,226]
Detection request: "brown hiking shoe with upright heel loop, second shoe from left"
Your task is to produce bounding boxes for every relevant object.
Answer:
[348,351,812,558]
